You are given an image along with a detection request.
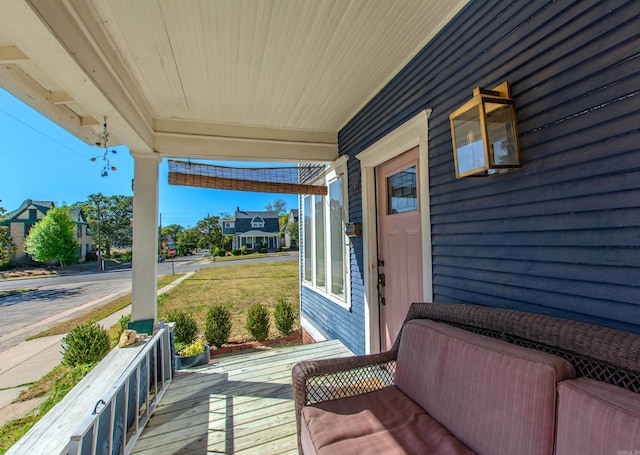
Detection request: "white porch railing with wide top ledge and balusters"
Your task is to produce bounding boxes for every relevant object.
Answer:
[5,322,174,455]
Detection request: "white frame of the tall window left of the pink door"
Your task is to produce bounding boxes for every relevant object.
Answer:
[301,156,351,310]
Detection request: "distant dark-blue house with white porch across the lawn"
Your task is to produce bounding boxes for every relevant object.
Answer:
[228,207,280,250]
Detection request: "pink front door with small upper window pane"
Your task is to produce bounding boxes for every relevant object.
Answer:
[376,147,423,350]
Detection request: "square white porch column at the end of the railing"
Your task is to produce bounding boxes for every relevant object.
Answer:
[131,151,162,321]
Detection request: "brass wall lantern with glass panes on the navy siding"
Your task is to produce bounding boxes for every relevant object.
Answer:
[449,82,520,178]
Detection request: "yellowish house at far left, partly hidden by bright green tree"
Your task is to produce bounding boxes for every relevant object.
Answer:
[3,199,93,265]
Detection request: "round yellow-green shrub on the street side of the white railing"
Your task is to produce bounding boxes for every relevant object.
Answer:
[62,322,111,367]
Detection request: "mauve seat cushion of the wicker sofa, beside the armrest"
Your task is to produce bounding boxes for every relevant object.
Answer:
[300,386,473,455]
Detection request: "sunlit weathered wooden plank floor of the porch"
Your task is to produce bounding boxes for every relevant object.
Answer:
[132,341,353,455]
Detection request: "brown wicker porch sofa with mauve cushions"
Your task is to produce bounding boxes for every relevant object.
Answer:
[293,303,640,455]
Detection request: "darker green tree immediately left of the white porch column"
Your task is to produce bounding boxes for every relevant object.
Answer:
[73,193,133,256]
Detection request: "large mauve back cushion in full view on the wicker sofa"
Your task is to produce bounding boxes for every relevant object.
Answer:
[396,320,575,455]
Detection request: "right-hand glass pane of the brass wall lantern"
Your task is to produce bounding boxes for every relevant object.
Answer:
[485,102,520,166]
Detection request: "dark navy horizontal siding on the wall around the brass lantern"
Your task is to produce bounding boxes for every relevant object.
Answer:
[339,0,640,332]
